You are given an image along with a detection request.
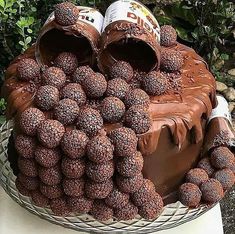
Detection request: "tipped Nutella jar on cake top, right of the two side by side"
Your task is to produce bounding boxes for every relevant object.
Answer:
[98,0,160,72]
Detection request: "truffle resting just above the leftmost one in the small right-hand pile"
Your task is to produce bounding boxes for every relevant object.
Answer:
[185,168,209,186]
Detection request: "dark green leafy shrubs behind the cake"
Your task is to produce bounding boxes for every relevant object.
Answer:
[0,0,235,114]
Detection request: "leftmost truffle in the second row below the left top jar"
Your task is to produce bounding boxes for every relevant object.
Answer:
[35,85,59,111]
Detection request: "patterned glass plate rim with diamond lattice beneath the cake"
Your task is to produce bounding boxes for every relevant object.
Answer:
[0,121,212,233]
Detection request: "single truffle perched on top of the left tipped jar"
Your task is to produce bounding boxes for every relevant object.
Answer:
[55,2,79,26]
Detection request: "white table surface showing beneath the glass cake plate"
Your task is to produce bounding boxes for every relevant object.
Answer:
[0,186,224,234]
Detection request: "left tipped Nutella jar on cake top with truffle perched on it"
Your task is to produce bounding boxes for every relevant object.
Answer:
[35,6,104,65]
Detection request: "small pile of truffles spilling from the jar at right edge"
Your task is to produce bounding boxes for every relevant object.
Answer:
[179,130,235,207]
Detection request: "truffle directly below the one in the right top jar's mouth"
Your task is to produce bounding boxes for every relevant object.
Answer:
[106,78,130,100]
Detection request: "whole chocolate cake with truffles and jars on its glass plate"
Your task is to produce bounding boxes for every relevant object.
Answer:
[0,0,235,233]
